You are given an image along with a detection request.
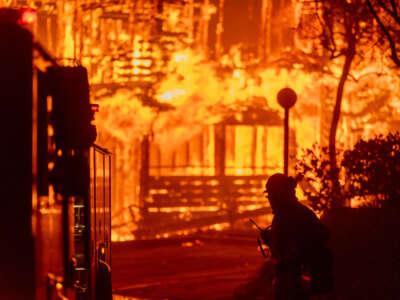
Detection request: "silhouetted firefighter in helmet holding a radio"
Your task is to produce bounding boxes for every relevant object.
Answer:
[237,173,333,300]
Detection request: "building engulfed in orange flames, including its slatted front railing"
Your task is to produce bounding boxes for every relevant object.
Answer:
[7,0,399,239]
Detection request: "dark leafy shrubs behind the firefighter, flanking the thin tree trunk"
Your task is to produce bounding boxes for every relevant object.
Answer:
[296,132,400,212]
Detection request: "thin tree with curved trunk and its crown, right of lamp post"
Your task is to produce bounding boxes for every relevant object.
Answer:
[300,0,376,206]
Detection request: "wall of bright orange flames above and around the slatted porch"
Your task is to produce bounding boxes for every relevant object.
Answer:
[8,0,400,239]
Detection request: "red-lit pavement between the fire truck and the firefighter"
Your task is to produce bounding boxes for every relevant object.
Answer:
[112,236,265,300]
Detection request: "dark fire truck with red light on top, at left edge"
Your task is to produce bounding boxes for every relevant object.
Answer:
[0,8,111,300]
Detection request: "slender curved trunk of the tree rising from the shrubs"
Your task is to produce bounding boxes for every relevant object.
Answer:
[329,42,355,207]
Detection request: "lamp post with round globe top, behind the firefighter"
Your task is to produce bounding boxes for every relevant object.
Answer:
[277,88,297,176]
